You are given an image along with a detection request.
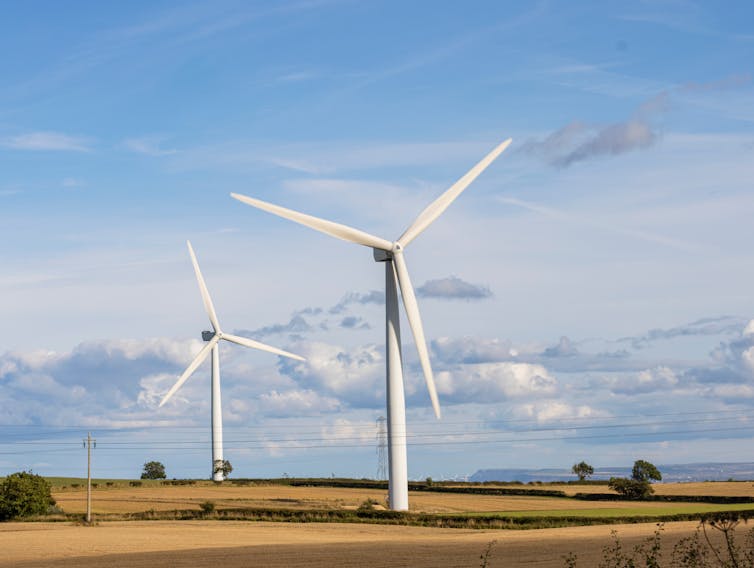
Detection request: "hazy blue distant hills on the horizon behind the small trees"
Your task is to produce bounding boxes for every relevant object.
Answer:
[469,462,754,483]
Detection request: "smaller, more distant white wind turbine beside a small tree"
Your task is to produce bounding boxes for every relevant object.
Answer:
[160,241,305,481]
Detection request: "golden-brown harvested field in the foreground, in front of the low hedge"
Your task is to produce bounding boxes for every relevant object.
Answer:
[0,521,708,568]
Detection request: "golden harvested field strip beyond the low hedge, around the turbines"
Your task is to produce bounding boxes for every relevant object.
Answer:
[48,481,754,517]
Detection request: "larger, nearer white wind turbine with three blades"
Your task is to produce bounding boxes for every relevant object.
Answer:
[231,139,511,511]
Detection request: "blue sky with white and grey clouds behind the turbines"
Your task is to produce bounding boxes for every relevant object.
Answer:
[0,0,754,479]
